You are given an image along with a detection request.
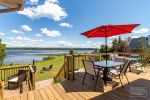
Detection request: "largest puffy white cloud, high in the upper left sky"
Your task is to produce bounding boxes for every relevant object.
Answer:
[18,0,68,21]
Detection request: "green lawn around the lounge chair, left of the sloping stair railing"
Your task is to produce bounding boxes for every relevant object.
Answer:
[35,55,64,81]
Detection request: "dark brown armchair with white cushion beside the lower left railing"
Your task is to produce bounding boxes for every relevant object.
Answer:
[8,70,27,93]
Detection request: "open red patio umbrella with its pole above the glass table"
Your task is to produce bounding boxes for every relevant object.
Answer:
[81,24,140,61]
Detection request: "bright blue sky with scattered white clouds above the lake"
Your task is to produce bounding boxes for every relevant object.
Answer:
[0,0,150,48]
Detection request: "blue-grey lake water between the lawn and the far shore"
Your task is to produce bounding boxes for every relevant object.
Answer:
[4,50,93,64]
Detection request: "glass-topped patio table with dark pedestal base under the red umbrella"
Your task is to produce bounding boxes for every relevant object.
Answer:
[94,60,124,85]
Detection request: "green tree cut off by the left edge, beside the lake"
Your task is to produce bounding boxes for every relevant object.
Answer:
[0,39,7,66]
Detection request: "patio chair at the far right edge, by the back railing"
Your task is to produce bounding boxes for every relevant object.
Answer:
[131,57,150,74]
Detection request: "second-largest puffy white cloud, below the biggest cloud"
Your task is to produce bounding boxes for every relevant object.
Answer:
[41,28,61,37]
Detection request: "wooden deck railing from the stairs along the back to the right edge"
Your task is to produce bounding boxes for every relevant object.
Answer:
[54,53,150,82]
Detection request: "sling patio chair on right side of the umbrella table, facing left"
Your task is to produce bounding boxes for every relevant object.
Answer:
[110,61,131,87]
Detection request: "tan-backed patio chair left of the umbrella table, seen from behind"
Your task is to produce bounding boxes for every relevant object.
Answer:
[82,60,102,90]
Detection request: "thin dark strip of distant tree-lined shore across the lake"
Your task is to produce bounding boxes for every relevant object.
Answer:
[6,47,95,50]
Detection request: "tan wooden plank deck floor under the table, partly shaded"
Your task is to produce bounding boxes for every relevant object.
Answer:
[4,71,150,100]
